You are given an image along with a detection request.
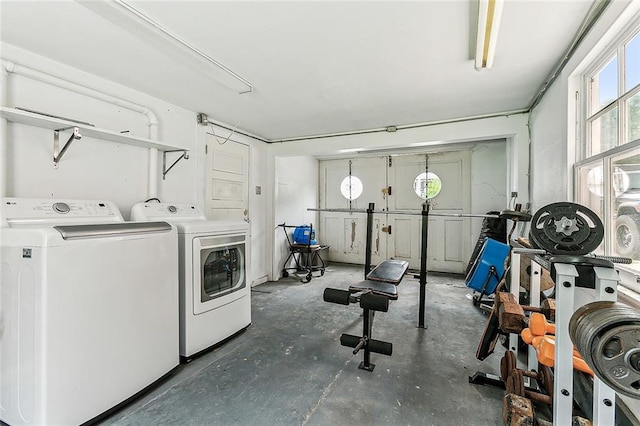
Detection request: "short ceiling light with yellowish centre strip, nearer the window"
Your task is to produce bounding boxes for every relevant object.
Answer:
[475,0,504,70]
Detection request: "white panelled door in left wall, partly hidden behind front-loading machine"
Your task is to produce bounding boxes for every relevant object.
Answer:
[205,133,249,221]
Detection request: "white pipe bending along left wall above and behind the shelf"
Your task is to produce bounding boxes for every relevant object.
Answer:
[0,60,158,198]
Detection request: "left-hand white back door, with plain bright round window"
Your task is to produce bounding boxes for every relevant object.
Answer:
[318,157,387,264]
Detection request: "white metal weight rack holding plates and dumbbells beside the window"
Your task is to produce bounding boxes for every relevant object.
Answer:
[509,244,619,425]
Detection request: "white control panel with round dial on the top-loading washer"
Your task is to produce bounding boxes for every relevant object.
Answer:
[0,198,124,226]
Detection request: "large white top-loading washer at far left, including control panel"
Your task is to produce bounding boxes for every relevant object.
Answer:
[0,198,180,426]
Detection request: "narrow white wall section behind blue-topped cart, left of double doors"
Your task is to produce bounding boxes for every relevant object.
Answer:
[273,156,318,279]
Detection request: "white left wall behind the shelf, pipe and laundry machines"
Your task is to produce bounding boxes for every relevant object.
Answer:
[0,44,271,280]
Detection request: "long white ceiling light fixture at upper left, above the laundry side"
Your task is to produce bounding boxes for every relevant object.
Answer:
[76,0,253,94]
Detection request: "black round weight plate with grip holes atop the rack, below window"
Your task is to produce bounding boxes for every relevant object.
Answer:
[529,203,604,255]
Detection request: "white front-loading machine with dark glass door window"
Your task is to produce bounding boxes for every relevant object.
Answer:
[131,203,251,361]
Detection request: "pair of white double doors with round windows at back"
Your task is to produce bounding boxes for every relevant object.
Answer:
[318,150,471,273]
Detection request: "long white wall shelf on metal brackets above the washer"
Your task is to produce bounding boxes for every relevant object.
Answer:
[0,107,186,151]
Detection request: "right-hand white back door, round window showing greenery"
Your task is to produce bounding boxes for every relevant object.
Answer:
[388,151,471,273]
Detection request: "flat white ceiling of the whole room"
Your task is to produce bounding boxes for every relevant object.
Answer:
[0,0,592,141]
